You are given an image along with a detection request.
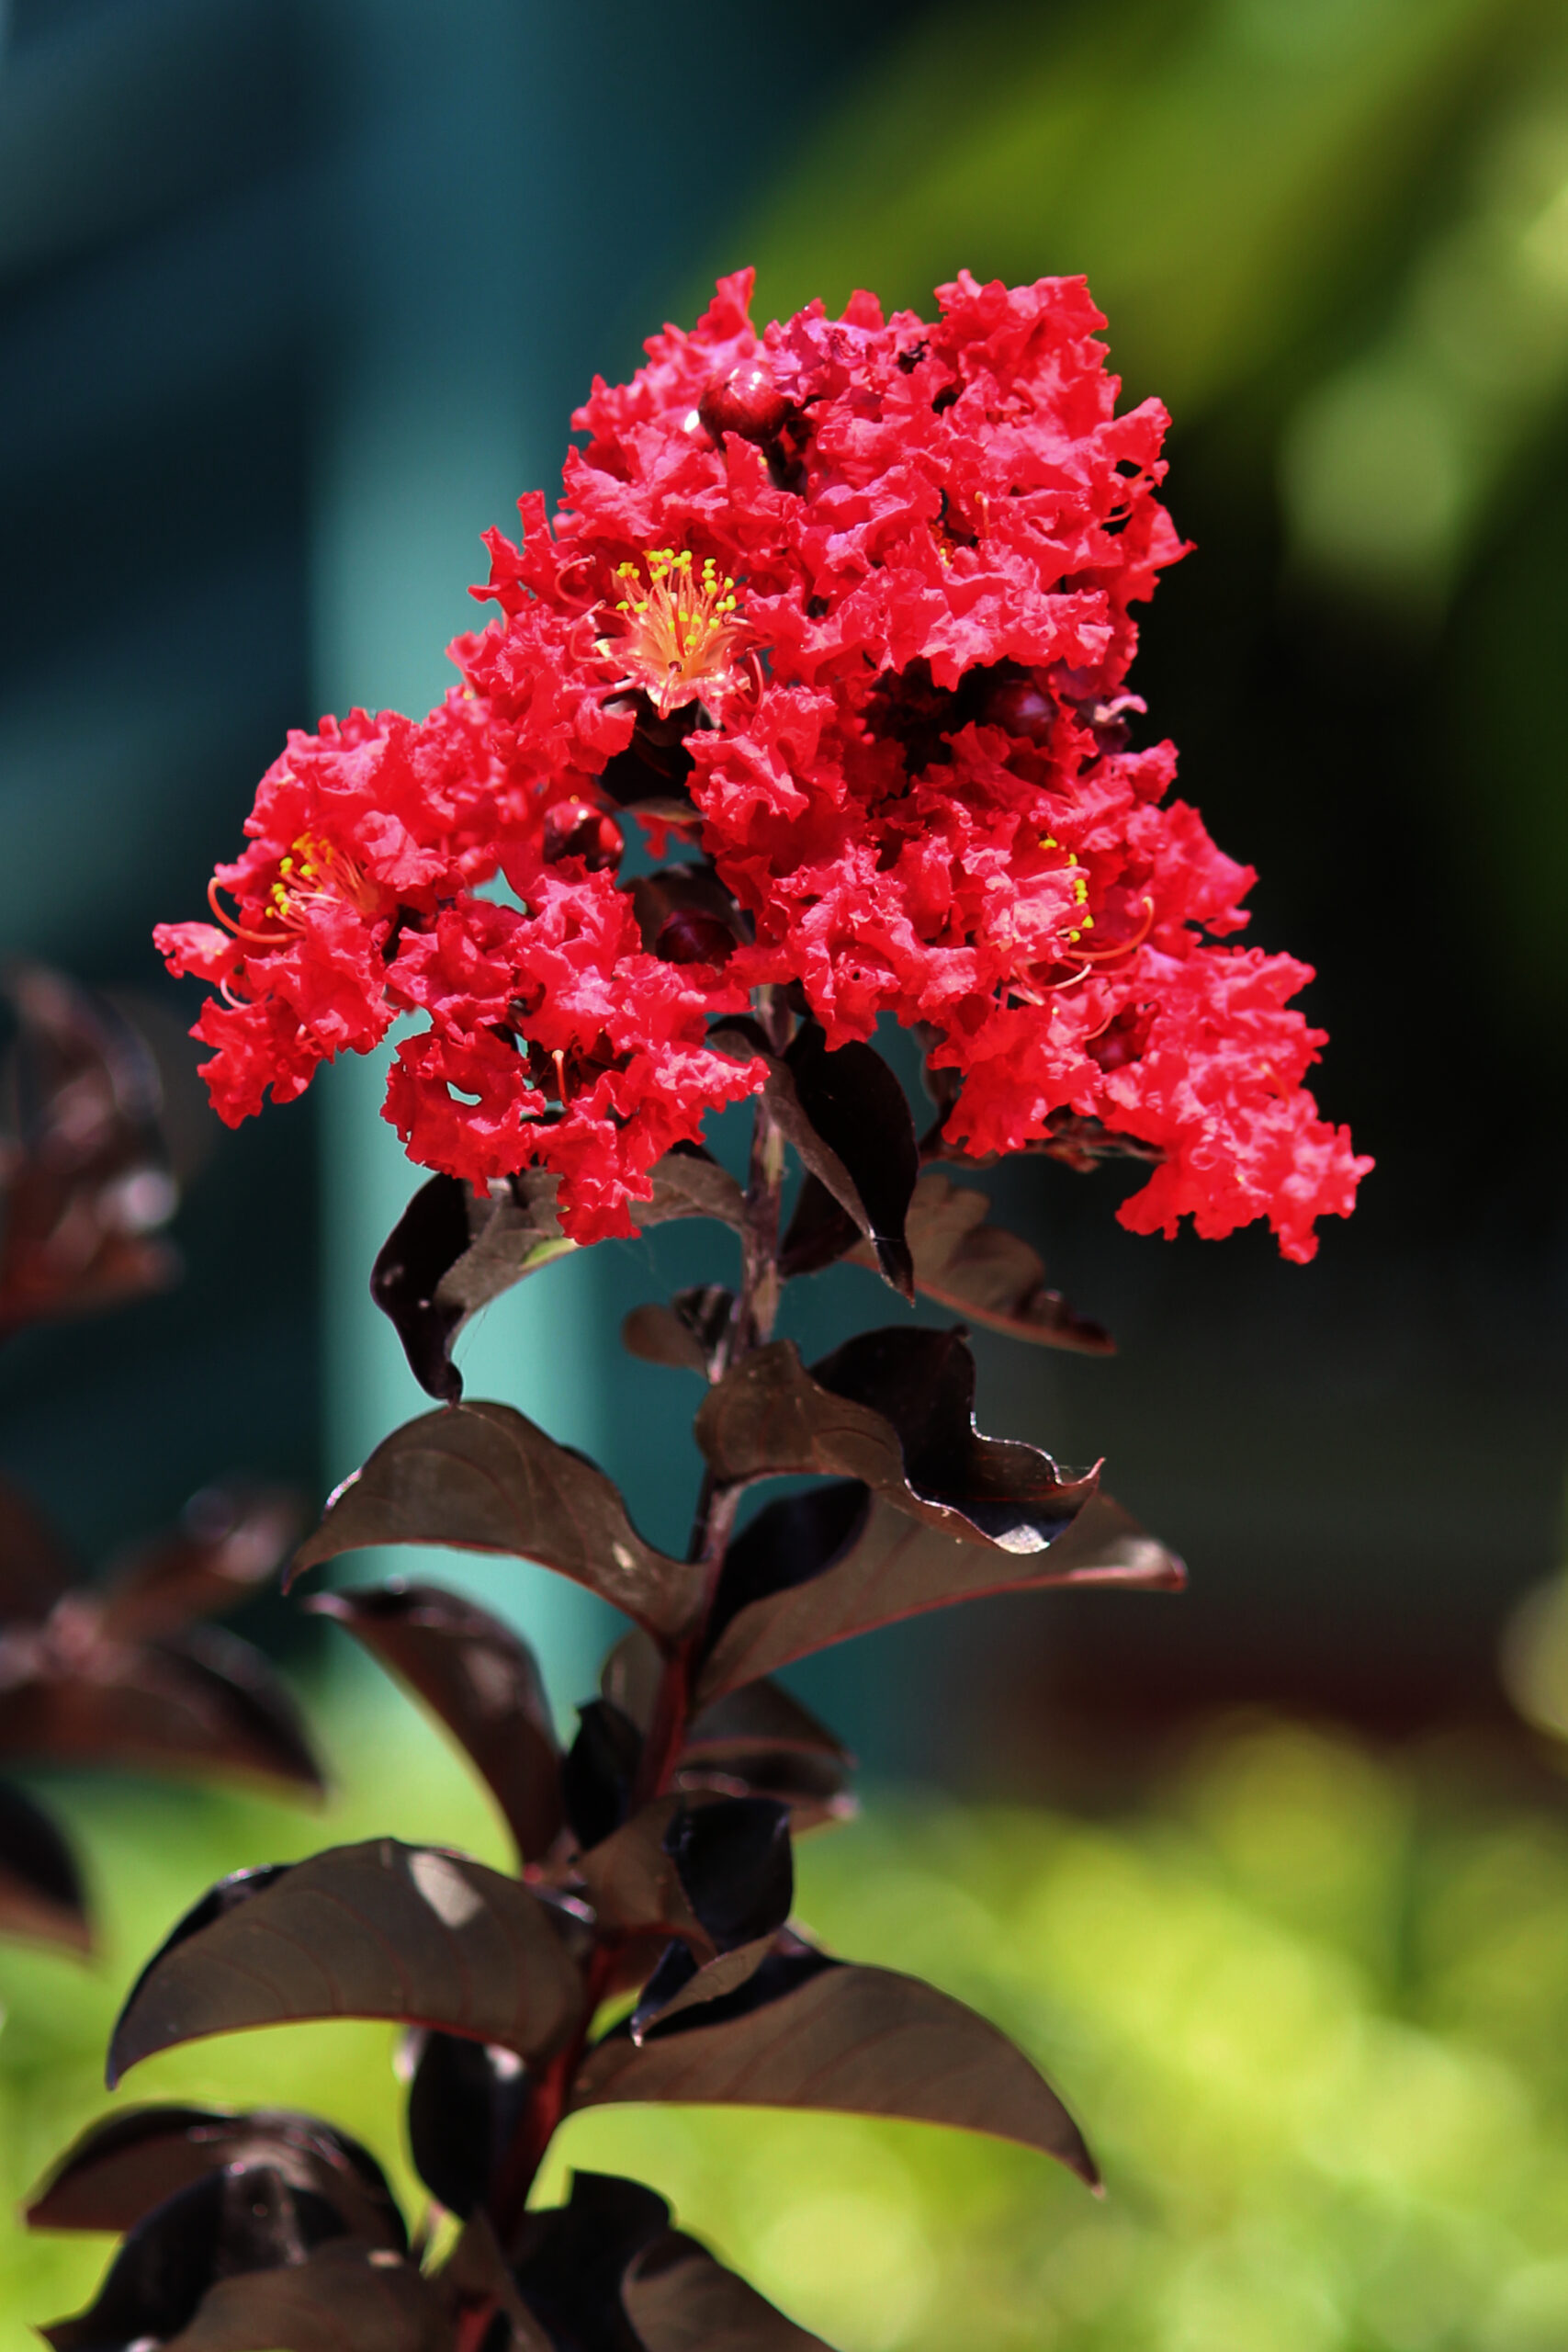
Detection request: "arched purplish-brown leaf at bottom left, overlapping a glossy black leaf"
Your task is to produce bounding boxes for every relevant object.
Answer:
[26,2108,409,2251]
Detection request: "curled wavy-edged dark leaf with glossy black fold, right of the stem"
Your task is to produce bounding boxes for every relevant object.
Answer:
[696,1329,1098,1553]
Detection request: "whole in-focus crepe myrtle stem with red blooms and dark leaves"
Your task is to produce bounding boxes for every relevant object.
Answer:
[33,276,1368,2352]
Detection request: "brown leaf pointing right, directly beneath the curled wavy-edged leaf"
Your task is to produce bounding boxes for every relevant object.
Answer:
[696,1484,1185,1705]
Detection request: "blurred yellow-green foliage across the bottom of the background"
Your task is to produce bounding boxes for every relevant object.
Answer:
[0,1708,1568,2352]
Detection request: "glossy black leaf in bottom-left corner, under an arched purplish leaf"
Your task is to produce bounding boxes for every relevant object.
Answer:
[42,2164,352,2352]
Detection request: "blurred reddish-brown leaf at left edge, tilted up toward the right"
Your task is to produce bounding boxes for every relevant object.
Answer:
[94,1487,303,1642]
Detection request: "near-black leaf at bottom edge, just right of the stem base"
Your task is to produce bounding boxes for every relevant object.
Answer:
[513,2173,670,2352]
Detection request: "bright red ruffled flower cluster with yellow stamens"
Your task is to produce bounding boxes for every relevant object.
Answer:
[160,273,1371,1259]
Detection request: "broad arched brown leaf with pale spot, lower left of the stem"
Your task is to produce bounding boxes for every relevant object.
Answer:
[108,1837,583,2088]
